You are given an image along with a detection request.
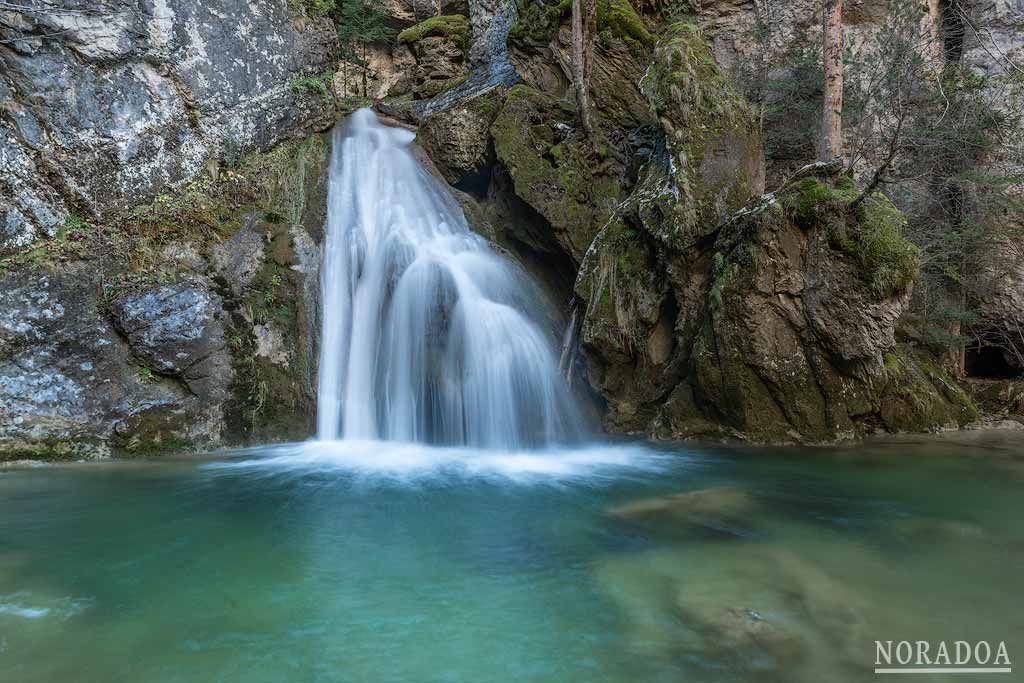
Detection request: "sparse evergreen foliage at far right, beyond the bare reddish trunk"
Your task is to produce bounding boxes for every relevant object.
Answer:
[844,3,1024,357]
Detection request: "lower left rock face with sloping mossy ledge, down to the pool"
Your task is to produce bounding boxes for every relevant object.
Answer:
[0,125,329,460]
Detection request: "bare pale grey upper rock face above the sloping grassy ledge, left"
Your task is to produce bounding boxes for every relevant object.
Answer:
[0,0,337,252]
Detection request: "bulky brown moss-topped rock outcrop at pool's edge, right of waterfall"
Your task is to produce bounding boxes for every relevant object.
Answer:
[578,171,977,442]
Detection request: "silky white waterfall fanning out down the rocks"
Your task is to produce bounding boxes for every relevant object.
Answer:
[317,109,580,447]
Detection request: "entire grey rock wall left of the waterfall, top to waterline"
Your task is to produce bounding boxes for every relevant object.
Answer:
[0,0,338,458]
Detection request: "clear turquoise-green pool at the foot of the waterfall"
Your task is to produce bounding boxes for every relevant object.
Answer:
[0,438,1024,682]
